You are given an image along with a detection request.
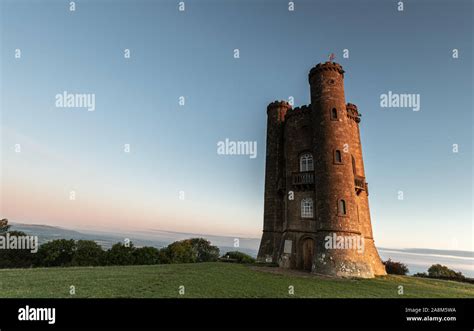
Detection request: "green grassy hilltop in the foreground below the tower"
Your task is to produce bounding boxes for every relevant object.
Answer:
[0,263,474,298]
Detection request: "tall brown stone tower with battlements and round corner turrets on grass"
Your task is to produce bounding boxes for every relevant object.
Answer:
[258,62,386,278]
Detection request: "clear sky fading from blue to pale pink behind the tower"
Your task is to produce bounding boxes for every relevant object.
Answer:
[0,0,473,250]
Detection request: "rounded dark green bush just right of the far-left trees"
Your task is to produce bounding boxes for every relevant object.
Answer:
[35,239,76,267]
